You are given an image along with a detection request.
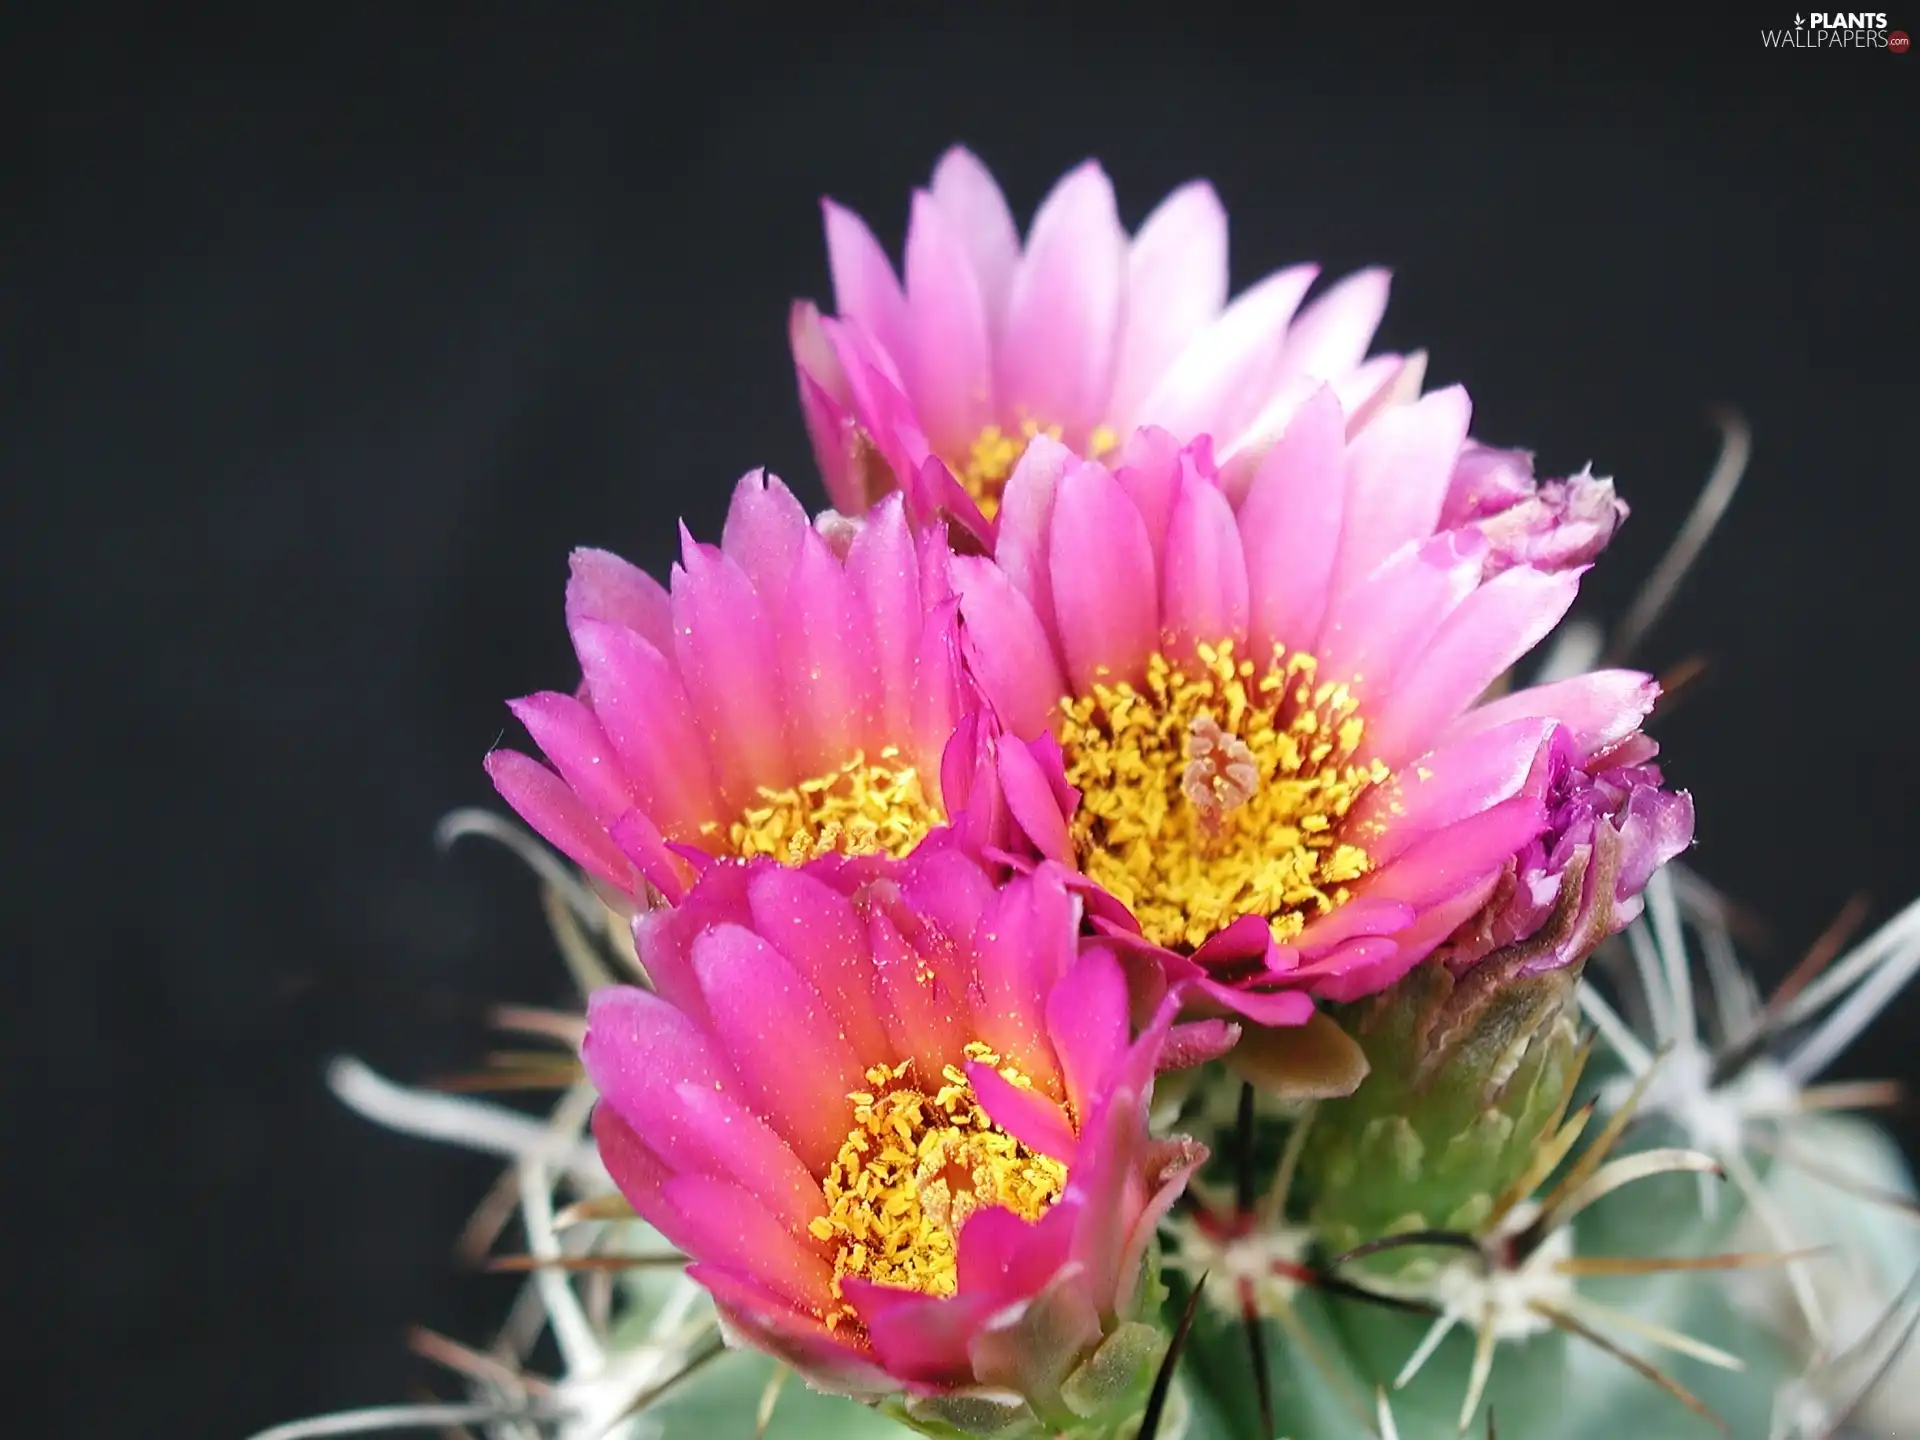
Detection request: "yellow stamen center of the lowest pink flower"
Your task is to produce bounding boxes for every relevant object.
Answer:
[808,1041,1068,1329]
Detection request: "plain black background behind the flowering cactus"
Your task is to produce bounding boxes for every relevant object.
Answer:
[0,6,1920,1436]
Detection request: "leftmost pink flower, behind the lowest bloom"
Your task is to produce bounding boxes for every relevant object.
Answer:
[488,472,1031,900]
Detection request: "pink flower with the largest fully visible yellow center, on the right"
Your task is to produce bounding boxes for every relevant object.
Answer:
[954,388,1681,1025]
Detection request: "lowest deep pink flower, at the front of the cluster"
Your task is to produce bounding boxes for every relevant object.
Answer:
[582,849,1206,1434]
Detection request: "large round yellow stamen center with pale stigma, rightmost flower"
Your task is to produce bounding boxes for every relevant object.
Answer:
[1060,641,1388,948]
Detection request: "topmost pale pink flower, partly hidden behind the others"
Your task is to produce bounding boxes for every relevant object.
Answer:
[791,148,1421,541]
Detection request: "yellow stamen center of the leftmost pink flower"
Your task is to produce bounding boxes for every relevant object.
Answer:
[708,745,947,864]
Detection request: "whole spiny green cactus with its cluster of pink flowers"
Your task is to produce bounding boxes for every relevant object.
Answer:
[259,150,1920,1440]
